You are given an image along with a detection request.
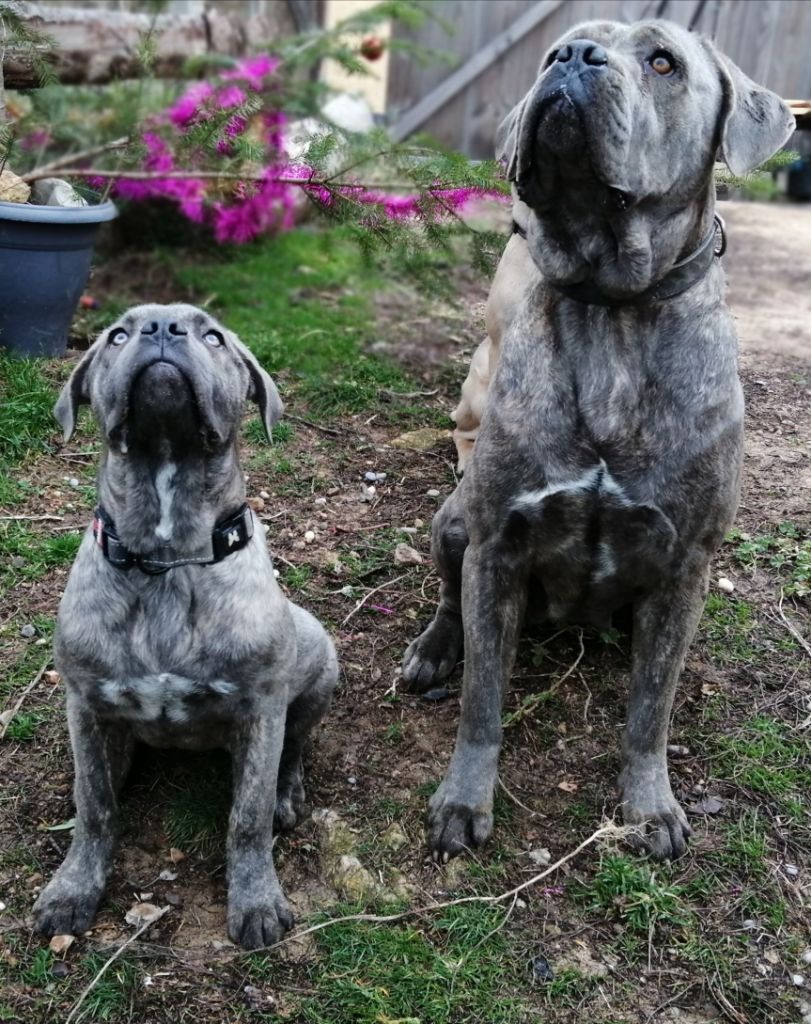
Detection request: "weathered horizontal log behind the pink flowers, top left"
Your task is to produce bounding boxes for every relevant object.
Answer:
[3,2,303,89]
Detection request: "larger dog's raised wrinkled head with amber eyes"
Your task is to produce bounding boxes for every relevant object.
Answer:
[498,20,794,292]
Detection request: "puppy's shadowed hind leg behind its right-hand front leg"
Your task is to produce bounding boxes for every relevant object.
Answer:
[273,627,338,831]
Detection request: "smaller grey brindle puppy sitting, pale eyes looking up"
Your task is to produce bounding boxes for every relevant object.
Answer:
[34,305,338,948]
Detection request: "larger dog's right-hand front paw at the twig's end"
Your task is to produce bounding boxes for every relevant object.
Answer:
[620,772,692,860]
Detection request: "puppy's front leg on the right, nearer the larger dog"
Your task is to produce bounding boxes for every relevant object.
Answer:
[227,692,293,949]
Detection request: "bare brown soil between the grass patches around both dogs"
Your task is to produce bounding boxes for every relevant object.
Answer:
[0,195,811,1024]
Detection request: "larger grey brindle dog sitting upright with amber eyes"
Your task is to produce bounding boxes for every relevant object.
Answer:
[403,22,794,860]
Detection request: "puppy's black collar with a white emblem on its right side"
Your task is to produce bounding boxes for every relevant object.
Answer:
[93,505,253,575]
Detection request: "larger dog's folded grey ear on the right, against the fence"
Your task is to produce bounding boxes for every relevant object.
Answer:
[715,50,796,174]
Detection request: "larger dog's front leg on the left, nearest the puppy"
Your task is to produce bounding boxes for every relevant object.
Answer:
[428,543,526,861]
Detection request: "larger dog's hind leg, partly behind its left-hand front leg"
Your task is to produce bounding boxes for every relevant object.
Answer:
[402,483,468,692]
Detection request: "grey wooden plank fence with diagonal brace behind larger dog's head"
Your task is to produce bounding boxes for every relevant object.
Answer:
[387,0,811,158]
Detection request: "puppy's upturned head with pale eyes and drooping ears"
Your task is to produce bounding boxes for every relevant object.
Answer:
[53,303,283,450]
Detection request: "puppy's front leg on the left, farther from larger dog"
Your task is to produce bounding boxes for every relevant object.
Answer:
[34,688,133,935]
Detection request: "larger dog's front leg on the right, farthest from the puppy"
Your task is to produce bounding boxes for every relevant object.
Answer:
[620,566,709,860]
